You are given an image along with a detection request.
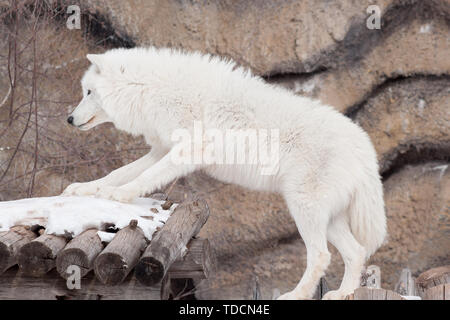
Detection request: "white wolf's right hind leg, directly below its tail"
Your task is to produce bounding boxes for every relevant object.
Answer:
[323,214,366,300]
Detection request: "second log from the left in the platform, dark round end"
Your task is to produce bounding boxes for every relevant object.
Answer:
[18,234,67,277]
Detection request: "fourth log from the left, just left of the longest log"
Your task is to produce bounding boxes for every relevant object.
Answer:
[94,220,147,285]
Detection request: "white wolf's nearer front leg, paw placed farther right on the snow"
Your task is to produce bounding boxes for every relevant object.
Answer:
[97,147,201,202]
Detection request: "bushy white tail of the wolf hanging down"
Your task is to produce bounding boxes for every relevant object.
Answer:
[349,174,386,259]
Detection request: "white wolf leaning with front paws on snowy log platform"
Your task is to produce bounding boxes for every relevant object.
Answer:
[63,48,386,299]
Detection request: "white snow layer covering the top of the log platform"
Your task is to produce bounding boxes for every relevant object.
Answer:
[0,196,176,241]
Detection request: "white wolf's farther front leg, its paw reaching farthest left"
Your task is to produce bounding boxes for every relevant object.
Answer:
[62,146,167,196]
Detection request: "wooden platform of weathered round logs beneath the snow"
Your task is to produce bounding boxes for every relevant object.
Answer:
[0,195,215,299]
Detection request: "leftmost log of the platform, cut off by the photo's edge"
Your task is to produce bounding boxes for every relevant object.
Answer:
[0,226,36,274]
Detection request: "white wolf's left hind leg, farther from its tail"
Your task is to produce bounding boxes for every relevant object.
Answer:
[278,197,330,300]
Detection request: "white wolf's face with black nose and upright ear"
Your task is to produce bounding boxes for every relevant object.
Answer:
[67,54,112,130]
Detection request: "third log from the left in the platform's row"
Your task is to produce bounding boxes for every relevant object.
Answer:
[56,229,103,279]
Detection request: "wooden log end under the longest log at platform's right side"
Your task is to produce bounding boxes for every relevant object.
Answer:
[169,239,217,279]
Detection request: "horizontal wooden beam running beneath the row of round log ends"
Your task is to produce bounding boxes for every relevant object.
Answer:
[0,267,160,300]
